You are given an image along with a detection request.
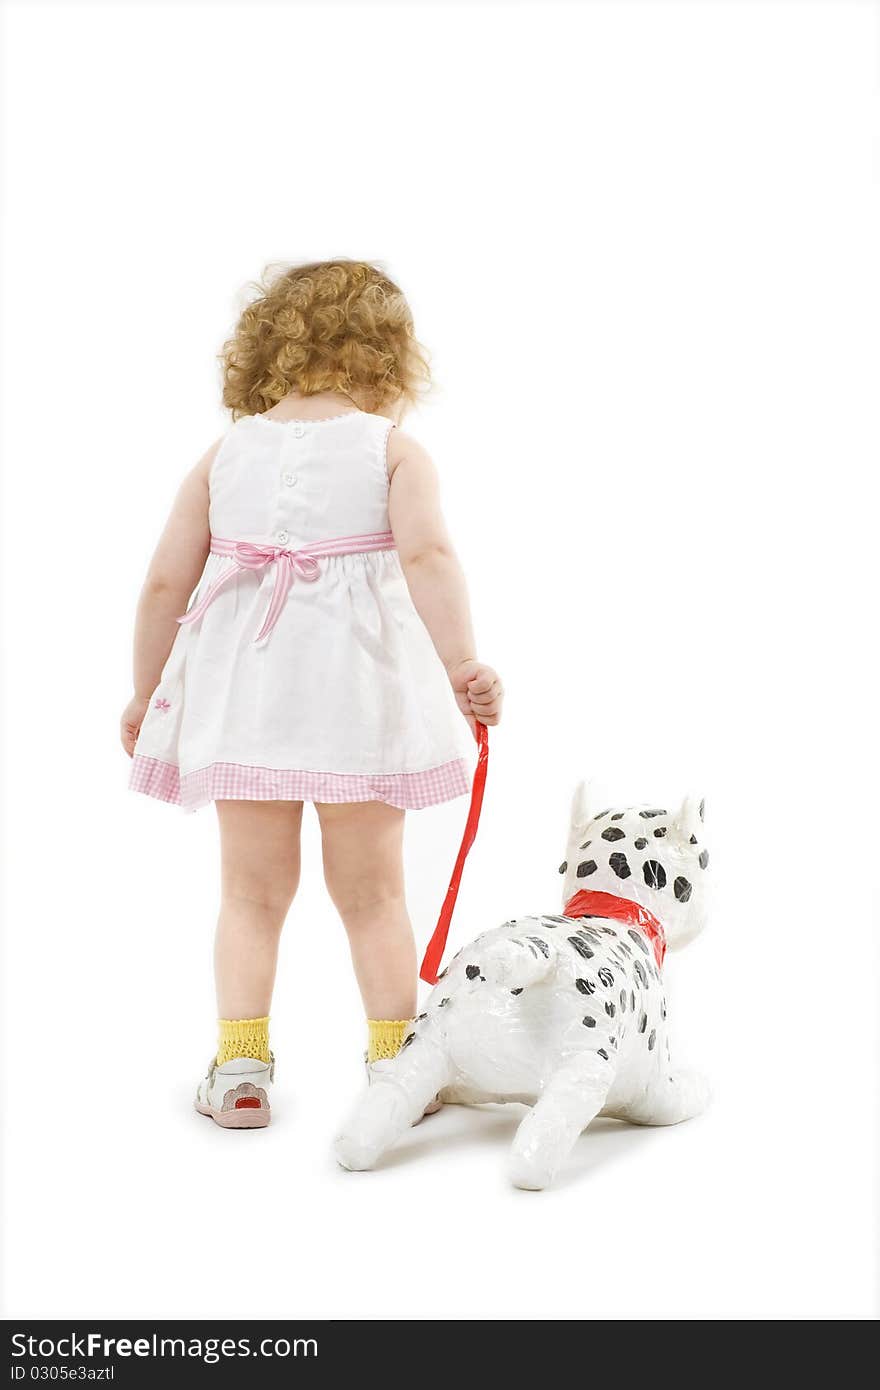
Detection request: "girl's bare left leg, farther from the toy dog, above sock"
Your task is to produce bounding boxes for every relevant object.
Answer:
[214,801,303,1019]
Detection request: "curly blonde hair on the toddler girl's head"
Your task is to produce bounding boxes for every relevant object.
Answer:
[220,260,431,420]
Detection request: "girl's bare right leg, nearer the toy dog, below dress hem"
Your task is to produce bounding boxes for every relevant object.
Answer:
[317,801,418,1019]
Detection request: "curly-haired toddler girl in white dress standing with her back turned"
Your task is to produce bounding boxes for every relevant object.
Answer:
[121,260,502,1129]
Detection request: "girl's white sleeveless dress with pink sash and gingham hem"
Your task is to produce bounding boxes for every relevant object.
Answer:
[131,410,468,810]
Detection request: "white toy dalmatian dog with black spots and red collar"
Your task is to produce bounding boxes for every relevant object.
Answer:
[336,788,709,1188]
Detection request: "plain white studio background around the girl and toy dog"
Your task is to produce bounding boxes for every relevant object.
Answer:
[3,3,880,1319]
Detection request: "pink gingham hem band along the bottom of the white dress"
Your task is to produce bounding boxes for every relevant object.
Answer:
[129,755,470,810]
